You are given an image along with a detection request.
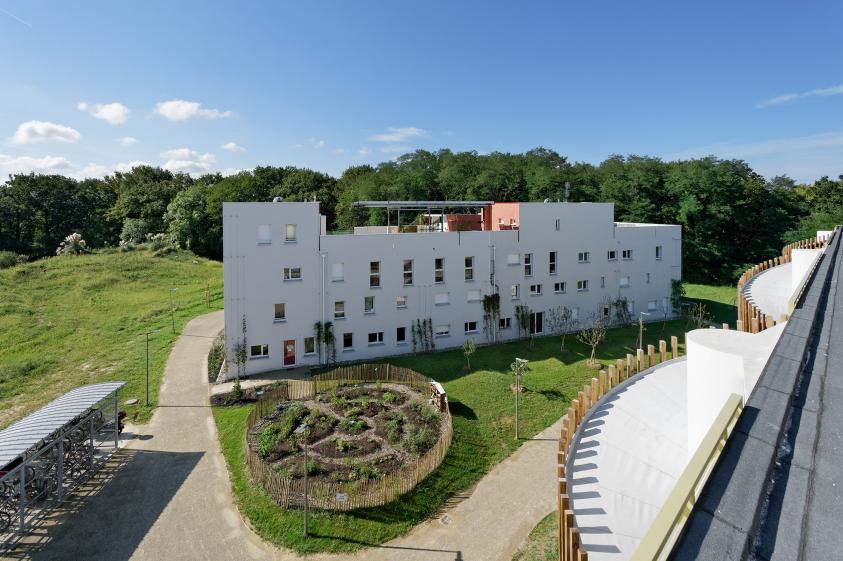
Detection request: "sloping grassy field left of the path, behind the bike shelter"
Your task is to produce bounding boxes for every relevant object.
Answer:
[0,250,222,427]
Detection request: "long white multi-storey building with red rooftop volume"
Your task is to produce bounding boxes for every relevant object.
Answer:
[223,202,682,376]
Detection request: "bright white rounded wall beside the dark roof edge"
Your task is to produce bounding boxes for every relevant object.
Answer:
[685,323,787,460]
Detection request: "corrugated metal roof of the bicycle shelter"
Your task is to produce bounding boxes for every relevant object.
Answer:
[0,382,126,466]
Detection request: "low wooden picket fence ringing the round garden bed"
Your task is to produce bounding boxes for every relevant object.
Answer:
[244,364,453,511]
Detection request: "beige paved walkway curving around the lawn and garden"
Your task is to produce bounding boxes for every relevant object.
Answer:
[18,312,561,561]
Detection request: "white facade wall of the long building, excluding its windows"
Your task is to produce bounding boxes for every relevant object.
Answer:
[223,199,681,375]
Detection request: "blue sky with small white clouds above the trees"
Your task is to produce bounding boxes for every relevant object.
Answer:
[0,0,843,181]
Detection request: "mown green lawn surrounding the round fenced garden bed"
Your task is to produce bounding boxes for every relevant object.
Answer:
[214,321,685,553]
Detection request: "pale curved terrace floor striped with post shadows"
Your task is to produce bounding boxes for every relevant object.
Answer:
[567,359,688,561]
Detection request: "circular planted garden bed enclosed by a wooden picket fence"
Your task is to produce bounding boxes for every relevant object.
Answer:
[246,373,451,510]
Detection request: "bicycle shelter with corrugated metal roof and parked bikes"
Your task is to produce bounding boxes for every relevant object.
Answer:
[0,382,125,545]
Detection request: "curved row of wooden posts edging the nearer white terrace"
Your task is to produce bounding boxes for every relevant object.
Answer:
[556,336,684,561]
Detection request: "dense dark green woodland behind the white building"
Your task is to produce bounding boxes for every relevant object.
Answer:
[0,148,843,283]
